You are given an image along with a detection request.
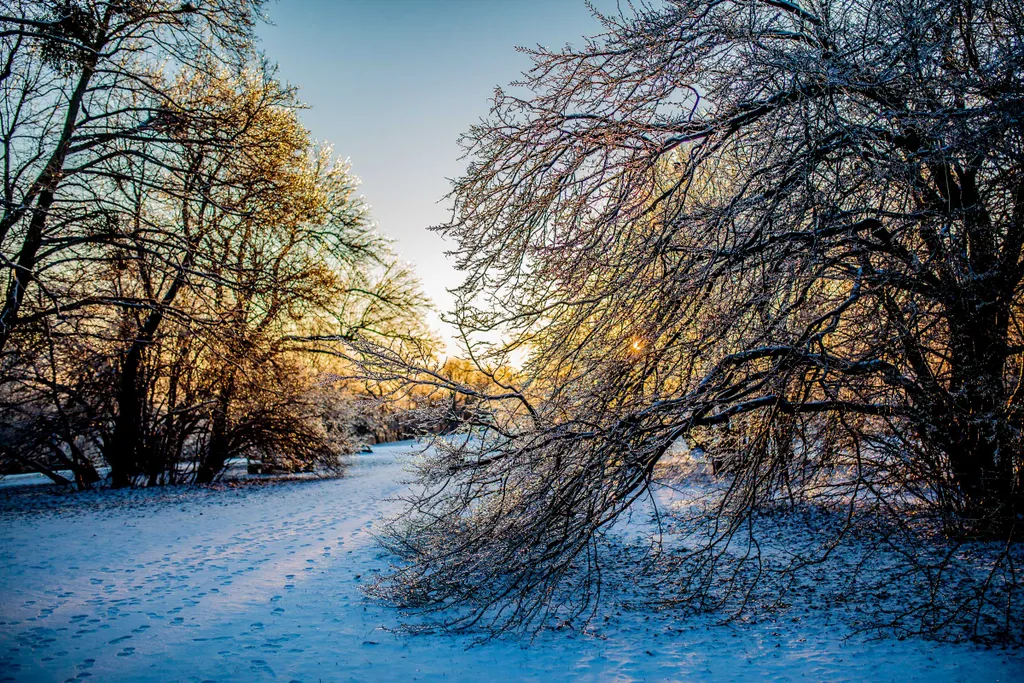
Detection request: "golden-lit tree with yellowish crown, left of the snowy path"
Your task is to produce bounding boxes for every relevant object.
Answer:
[80,65,422,485]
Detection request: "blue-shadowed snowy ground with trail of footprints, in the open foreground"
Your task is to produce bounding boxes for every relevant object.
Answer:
[0,443,1024,683]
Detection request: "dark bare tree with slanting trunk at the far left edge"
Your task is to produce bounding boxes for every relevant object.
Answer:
[0,0,260,352]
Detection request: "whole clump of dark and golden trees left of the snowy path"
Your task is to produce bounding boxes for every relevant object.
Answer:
[0,0,429,486]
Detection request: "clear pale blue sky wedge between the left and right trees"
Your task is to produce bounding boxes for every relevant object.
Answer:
[258,0,601,351]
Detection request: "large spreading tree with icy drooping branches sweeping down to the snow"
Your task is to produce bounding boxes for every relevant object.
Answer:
[375,0,1024,636]
